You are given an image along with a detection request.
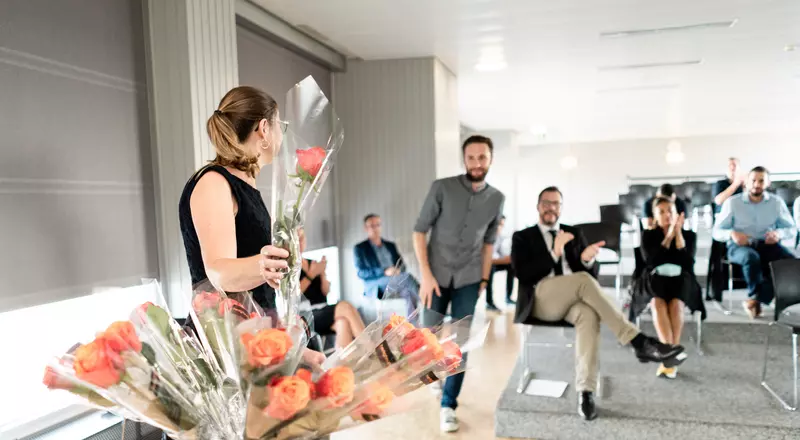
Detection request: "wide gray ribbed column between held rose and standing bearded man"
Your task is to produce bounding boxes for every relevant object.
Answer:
[334,58,456,304]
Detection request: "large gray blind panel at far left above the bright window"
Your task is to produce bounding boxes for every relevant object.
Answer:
[0,0,157,311]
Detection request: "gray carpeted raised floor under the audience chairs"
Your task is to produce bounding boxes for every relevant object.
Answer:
[495,322,800,440]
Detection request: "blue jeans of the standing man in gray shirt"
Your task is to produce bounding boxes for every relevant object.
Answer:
[423,283,480,409]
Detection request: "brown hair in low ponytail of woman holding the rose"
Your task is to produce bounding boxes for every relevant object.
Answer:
[206,86,278,177]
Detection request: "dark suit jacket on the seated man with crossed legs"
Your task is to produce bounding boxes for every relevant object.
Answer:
[511,225,597,323]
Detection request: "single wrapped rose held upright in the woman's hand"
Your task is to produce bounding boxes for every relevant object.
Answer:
[272,76,344,324]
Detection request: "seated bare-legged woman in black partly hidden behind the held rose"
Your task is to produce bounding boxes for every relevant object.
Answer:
[300,229,364,348]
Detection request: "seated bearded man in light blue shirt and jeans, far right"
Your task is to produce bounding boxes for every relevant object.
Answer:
[714,167,795,318]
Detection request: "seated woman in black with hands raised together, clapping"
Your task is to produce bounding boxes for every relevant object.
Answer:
[632,197,705,379]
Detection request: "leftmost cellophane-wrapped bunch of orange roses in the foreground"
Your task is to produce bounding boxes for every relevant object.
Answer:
[44,288,241,439]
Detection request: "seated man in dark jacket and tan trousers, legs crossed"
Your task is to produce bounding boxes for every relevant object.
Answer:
[511,187,686,420]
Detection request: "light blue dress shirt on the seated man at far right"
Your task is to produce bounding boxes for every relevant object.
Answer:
[714,192,796,241]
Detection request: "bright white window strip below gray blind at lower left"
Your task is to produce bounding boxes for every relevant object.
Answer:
[0,283,158,438]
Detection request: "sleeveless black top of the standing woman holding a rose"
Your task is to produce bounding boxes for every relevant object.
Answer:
[178,165,275,309]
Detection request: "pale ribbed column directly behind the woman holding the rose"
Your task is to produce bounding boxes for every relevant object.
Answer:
[143,0,239,316]
